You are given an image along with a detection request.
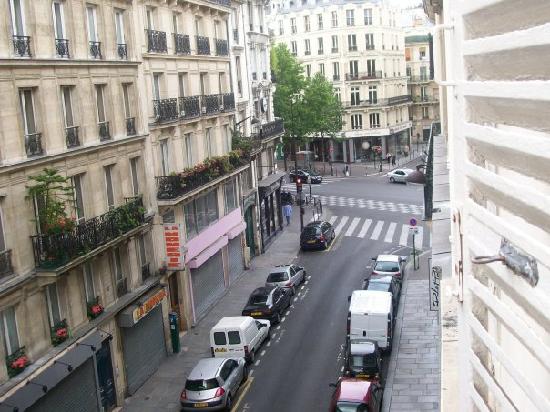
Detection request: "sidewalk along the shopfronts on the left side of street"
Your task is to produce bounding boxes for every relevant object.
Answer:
[123,211,304,412]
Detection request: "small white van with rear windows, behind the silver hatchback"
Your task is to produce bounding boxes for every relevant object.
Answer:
[210,316,271,363]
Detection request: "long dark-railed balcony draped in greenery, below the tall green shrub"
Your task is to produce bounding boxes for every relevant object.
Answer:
[31,197,145,270]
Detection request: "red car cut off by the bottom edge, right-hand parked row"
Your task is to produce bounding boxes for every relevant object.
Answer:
[330,378,384,412]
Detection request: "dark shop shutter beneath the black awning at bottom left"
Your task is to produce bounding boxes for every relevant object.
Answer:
[27,358,99,412]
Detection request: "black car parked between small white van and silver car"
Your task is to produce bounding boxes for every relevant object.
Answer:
[242,286,292,323]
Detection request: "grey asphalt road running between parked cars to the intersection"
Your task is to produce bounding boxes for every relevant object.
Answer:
[234,176,428,412]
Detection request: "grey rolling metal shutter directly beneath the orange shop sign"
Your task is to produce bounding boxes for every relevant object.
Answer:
[121,305,166,395]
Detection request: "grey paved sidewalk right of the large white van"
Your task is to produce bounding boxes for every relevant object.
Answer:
[382,251,441,412]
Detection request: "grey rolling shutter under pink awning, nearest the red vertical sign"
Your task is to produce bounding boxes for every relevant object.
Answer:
[191,250,225,320]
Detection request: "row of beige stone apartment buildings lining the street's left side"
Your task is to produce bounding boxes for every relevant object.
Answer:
[0,0,284,411]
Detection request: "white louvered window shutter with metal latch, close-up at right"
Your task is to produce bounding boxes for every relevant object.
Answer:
[430,0,550,411]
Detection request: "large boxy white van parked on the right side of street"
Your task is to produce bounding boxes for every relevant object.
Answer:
[348,290,393,352]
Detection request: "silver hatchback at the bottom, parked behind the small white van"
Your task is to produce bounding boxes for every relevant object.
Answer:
[180,358,248,411]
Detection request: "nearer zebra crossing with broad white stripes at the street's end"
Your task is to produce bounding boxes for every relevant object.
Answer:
[329,215,429,249]
